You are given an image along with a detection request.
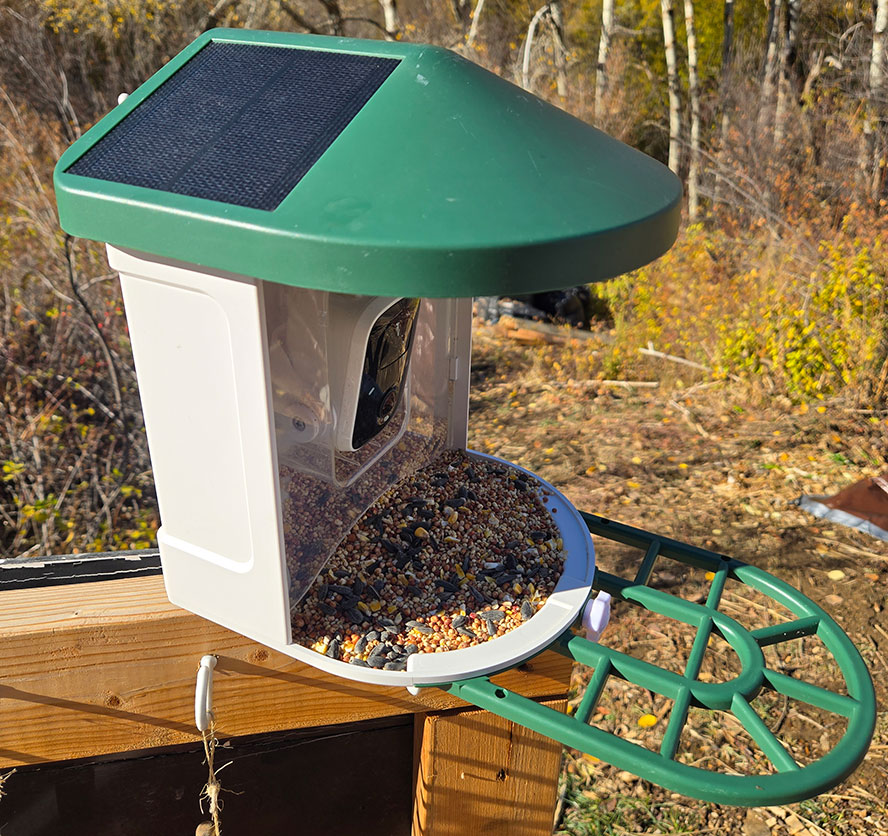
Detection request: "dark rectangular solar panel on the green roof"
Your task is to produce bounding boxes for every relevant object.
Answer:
[67,42,399,210]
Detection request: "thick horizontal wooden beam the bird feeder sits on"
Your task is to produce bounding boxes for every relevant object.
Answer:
[0,577,570,768]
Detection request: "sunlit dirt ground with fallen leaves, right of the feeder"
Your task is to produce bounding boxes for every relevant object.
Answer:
[469,326,888,836]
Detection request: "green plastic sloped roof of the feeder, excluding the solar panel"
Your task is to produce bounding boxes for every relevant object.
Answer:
[55,29,681,297]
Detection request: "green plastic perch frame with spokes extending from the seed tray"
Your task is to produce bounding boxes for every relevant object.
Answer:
[447,512,876,807]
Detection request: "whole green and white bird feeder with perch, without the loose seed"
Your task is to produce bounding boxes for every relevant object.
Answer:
[55,30,875,805]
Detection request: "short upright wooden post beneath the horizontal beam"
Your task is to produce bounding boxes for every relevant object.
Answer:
[413,699,566,836]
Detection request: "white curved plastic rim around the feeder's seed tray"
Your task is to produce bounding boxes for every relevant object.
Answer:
[274,451,595,687]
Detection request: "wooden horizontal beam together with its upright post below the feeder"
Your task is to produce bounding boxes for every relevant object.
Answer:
[0,576,571,836]
